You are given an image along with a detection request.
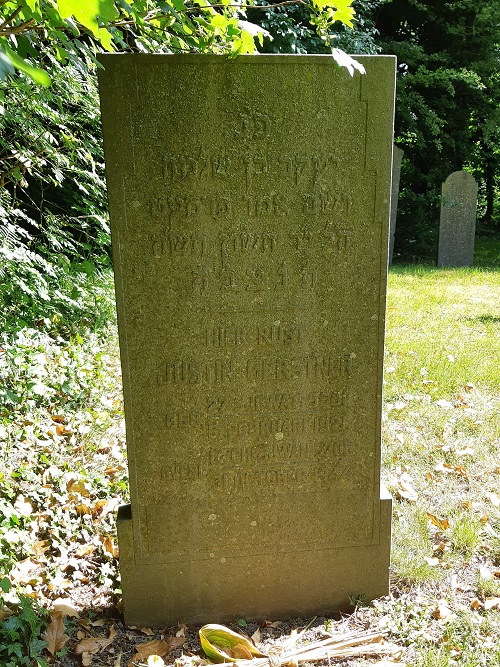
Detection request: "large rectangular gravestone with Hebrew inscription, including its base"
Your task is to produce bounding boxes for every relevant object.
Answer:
[99,54,395,626]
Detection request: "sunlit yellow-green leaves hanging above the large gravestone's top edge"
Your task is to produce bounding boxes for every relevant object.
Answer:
[0,0,354,86]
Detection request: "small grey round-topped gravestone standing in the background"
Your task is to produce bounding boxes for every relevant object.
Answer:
[438,171,477,267]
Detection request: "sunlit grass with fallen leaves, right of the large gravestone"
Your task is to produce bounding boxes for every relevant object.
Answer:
[376,254,500,667]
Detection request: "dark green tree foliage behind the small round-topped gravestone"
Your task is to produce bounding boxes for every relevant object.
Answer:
[376,0,500,258]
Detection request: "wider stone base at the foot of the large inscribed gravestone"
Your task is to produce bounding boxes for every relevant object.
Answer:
[117,491,392,626]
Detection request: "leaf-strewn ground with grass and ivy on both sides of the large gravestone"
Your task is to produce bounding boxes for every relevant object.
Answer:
[0,254,500,667]
